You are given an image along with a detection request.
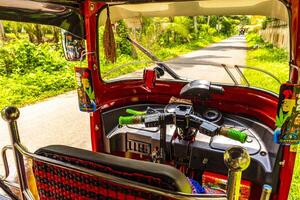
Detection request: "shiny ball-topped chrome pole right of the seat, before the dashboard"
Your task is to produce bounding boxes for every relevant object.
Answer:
[224,146,251,200]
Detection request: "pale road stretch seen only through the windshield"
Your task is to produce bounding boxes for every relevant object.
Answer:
[171,36,247,83]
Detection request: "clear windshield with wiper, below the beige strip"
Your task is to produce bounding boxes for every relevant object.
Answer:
[99,10,289,93]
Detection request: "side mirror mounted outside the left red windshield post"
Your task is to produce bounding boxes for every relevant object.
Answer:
[61,30,85,61]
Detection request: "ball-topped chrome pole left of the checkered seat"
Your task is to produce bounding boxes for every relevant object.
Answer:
[1,107,28,200]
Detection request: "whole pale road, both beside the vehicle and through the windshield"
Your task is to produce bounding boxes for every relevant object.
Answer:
[0,36,246,177]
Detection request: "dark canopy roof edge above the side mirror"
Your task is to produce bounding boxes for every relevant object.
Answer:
[0,0,84,37]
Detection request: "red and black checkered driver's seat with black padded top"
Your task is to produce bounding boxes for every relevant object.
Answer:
[33,145,191,200]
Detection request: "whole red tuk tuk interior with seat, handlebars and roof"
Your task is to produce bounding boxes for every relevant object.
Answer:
[0,0,300,200]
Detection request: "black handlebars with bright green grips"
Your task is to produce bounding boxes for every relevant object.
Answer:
[119,113,247,143]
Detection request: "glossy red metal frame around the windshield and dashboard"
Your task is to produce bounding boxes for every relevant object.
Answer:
[0,0,300,199]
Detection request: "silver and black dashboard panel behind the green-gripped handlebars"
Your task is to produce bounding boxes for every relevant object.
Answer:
[102,104,280,189]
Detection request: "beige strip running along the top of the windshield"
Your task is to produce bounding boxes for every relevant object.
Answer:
[101,0,289,22]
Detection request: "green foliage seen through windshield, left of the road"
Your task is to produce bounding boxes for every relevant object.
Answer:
[98,16,249,80]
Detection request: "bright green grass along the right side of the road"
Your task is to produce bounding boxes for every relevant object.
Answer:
[244,33,300,200]
